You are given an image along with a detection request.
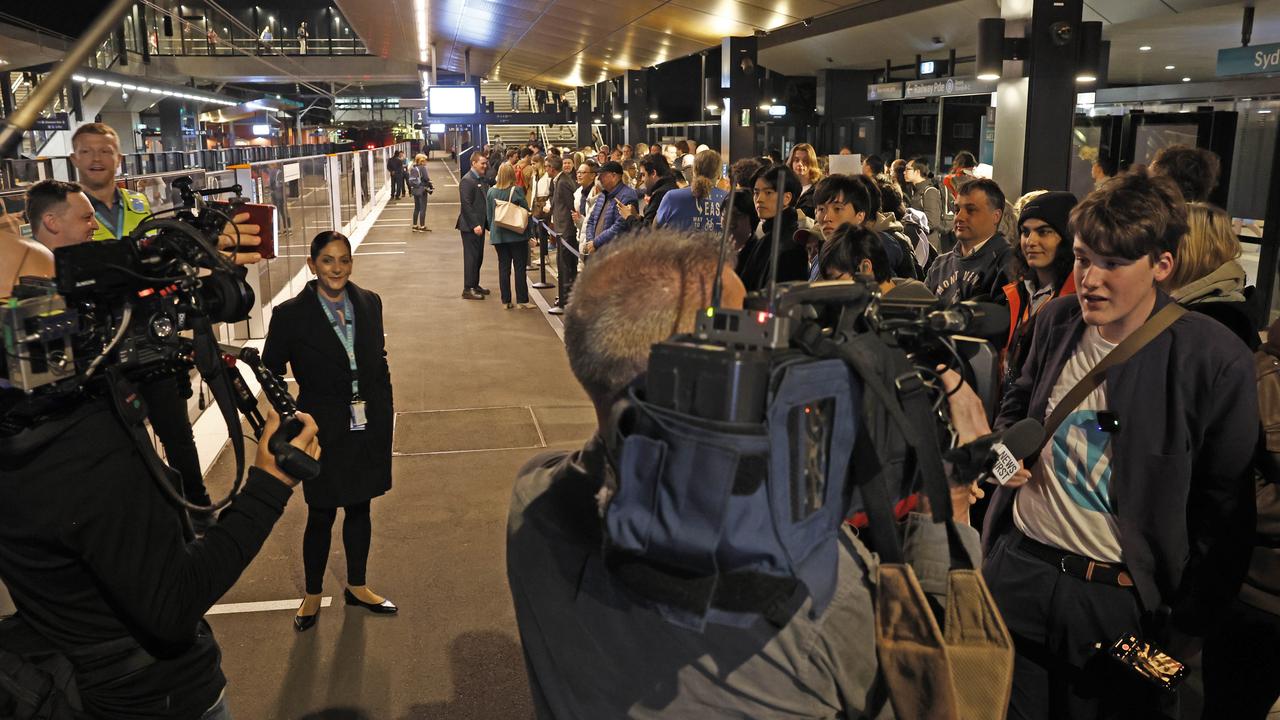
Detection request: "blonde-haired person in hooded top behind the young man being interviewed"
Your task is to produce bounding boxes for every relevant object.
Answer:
[1162,202,1261,350]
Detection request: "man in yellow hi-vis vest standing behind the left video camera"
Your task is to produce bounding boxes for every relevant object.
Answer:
[72,123,259,532]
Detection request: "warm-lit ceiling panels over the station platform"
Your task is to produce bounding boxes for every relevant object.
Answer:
[337,0,1280,87]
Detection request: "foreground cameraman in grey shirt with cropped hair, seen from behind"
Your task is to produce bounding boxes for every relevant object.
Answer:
[507,229,987,720]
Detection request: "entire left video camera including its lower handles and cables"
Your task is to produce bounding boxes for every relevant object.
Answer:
[0,177,319,511]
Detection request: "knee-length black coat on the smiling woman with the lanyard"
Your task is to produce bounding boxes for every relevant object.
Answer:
[262,281,396,507]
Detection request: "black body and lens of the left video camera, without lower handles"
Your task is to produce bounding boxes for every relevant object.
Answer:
[0,178,253,396]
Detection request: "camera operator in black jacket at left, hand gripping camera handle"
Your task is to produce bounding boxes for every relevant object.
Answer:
[0,333,319,720]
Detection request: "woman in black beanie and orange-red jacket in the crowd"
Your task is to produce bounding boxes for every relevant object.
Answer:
[1002,191,1076,387]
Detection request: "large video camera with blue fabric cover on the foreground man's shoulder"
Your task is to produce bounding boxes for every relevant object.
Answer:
[602,170,1007,630]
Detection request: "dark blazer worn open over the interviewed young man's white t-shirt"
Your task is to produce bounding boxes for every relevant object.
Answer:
[982,292,1258,635]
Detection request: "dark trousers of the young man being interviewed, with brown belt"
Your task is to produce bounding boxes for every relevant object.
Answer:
[982,528,1176,720]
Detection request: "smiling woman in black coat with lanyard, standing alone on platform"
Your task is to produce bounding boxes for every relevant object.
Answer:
[262,232,396,630]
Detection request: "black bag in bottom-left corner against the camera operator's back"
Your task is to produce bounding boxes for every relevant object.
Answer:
[0,615,86,720]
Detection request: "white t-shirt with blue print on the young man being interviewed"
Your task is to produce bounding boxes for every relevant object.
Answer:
[1014,325,1124,562]
